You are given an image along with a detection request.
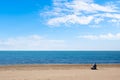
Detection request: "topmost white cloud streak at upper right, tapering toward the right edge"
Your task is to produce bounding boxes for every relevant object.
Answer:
[65,0,117,13]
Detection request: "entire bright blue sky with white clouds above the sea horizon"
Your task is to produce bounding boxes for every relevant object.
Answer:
[0,0,120,50]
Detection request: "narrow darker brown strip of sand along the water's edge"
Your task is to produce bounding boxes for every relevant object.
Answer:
[0,64,120,70]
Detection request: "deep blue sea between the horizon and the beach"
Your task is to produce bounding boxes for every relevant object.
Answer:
[0,51,120,65]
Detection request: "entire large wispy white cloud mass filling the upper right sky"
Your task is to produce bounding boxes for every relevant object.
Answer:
[43,0,120,26]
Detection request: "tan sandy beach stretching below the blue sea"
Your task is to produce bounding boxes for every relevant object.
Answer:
[0,64,120,80]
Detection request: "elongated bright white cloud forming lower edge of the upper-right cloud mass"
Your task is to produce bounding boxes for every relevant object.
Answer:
[48,15,93,25]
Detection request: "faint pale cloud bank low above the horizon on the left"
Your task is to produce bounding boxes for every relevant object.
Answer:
[0,35,66,50]
